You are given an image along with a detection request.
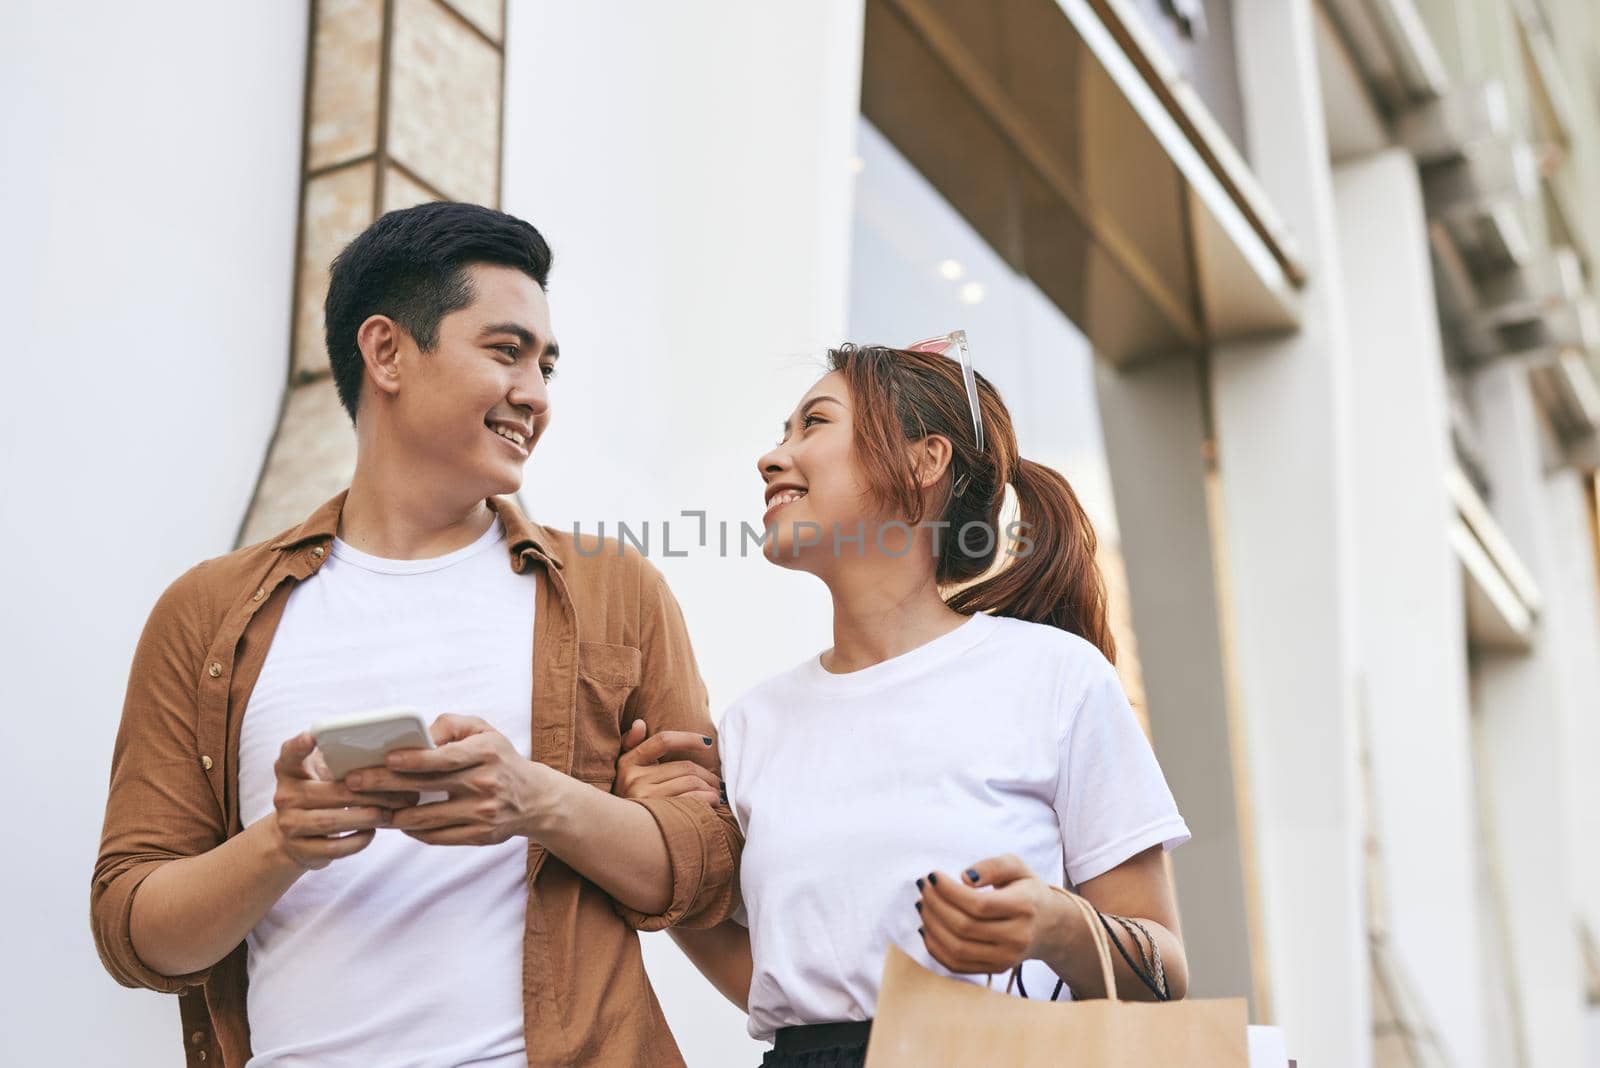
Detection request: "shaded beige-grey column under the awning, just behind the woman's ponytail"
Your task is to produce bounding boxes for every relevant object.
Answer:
[1096,357,1264,1018]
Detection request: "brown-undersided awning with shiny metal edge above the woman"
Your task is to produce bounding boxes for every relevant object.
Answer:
[861,0,1304,363]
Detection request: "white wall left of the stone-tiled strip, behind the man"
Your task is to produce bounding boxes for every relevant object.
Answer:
[0,0,306,1065]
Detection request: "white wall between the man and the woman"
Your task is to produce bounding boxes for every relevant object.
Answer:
[504,0,862,1065]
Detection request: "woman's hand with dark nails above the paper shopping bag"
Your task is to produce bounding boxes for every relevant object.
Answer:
[917,854,1083,974]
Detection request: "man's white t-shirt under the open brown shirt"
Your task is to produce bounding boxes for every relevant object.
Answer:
[238,520,534,1068]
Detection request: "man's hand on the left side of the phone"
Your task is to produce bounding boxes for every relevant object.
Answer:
[272,731,416,871]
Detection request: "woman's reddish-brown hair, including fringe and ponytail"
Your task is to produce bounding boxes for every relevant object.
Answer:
[827,345,1117,662]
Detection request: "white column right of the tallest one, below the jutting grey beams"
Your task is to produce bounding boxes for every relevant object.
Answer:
[1334,149,1498,1068]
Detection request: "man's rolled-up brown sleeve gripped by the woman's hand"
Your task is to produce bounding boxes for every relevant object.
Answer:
[616,560,744,931]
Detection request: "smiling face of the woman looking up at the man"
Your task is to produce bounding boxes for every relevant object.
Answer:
[757,371,874,571]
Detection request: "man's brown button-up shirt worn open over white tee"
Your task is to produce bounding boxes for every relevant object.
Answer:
[90,494,742,1068]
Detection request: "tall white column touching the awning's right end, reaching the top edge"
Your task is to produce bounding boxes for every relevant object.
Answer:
[1213,0,1371,1068]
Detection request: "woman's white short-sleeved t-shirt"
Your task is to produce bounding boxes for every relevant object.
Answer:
[720,614,1189,1039]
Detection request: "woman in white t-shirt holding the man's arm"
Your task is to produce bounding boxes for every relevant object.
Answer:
[618,334,1189,1066]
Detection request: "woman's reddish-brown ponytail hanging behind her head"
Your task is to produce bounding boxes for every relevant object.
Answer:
[949,457,1117,664]
